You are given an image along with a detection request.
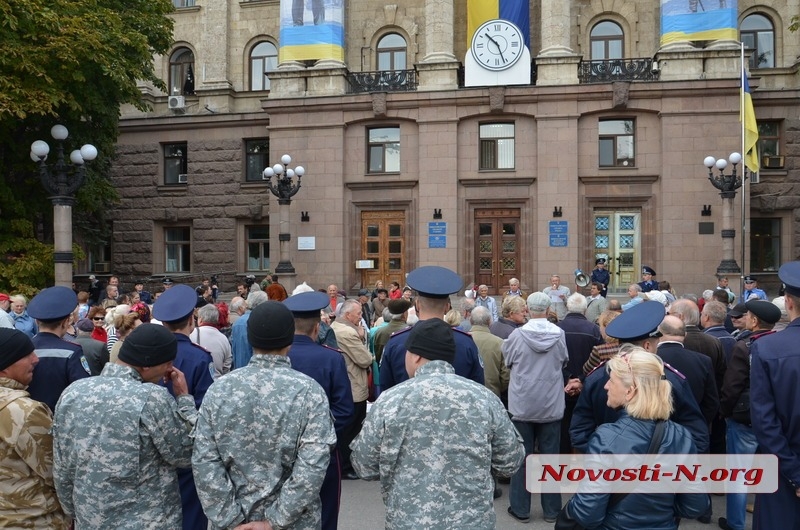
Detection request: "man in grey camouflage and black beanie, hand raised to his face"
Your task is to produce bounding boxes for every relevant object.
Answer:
[53,324,197,530]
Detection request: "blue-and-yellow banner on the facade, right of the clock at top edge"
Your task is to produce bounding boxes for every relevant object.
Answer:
[661,0,739,46]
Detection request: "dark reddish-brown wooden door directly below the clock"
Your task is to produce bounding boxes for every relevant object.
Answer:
[475,208,522,295]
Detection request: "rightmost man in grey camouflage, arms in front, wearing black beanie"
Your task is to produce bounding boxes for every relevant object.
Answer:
[352,318,525,529]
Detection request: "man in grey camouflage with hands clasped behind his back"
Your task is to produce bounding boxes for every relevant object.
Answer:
[192,301,336,530]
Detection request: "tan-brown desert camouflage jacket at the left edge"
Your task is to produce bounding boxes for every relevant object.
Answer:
[0,377,71,530]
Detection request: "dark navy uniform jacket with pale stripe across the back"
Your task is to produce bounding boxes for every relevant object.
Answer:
[28,332,91,411]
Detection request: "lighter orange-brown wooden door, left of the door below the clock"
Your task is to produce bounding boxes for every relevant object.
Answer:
[361,210,406,289]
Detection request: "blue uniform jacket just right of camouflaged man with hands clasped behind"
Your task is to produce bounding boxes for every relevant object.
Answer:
[289,335,353,438]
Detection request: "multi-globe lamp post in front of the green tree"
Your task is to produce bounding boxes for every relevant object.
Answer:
[31,125,97,287]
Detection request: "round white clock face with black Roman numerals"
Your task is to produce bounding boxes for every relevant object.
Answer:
[470,19,525,70]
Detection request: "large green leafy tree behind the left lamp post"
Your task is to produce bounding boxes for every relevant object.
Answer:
[0,0,174,293]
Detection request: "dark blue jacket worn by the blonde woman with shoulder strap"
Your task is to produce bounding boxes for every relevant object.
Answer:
[567,412,709,530]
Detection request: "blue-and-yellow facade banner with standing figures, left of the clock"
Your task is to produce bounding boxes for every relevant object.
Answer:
[278,0,344,62]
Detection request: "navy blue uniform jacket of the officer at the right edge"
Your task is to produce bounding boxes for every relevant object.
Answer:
[750,318,800,530]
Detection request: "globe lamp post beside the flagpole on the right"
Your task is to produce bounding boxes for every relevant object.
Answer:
[703,153,747,274]
